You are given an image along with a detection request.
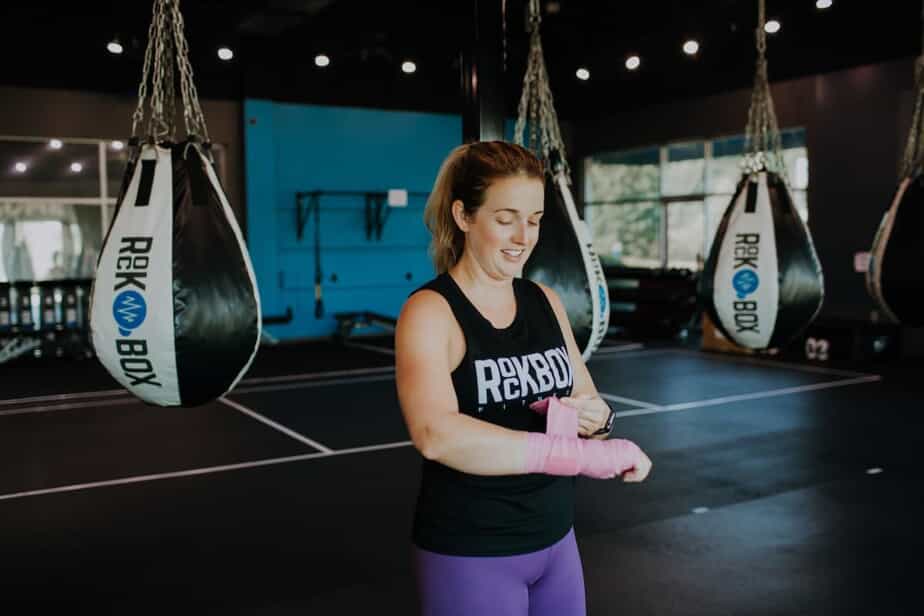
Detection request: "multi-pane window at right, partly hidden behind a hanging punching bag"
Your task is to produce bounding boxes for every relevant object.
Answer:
[584,129,808,270]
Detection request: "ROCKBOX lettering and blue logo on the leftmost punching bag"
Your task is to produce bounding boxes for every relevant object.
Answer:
[112,237,163,387]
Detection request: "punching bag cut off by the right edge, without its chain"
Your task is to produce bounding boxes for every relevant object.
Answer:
[866,172,924,327]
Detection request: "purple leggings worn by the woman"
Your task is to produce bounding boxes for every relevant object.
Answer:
[414,528,586,616]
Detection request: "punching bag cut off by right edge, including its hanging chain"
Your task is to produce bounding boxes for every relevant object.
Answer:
[866,3,924,327]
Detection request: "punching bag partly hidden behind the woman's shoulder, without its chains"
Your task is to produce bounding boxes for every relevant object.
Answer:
[523,152,610,361]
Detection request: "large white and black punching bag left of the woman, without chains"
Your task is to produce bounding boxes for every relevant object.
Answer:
[90,141,261,406]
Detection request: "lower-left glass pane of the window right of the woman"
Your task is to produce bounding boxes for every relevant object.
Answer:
[587,202,663,267]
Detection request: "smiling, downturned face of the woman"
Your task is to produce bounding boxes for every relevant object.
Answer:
[454,176,545,280]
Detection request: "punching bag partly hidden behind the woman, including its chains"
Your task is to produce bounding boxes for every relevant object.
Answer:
[514,0,610,361]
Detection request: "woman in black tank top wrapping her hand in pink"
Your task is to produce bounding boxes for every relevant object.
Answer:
[395,141,651,616]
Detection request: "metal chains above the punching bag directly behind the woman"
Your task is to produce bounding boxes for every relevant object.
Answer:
[513,0,571,184]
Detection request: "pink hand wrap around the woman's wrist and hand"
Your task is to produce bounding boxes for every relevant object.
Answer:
[526,398,642,479]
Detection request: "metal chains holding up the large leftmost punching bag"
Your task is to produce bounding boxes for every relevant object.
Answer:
[132,0,209,142]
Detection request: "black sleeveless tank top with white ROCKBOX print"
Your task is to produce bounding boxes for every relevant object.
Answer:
[413,273,575,556]
